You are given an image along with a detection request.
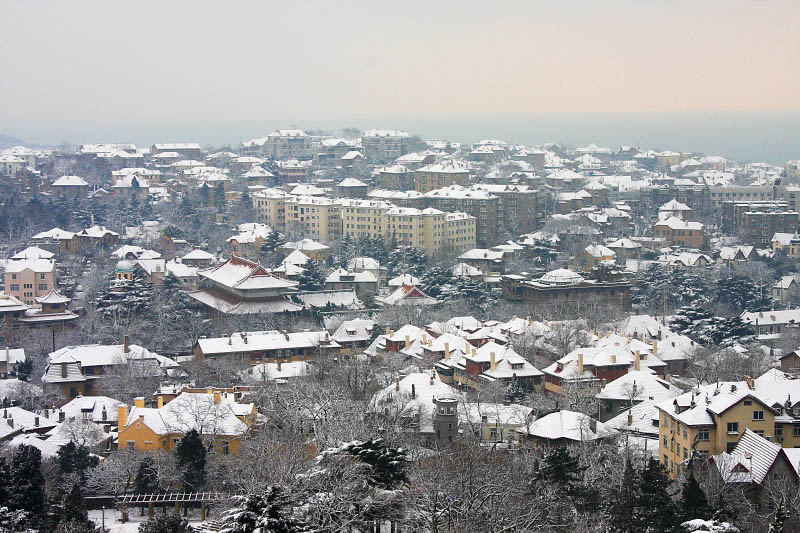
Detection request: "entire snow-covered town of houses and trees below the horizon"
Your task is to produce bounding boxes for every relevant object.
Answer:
[0,128,800,533]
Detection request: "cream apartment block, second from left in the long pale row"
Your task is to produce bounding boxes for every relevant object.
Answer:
[284,196,342,243]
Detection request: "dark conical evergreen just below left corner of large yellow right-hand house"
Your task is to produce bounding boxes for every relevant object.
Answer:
[636,457,680,532]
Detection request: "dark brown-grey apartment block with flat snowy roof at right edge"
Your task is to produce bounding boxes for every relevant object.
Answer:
[722,201,800,247]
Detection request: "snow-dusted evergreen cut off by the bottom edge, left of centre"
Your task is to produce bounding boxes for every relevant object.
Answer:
[225,486,311,533]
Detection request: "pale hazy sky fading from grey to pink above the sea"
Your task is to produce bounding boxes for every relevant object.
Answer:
[0,0,800,142]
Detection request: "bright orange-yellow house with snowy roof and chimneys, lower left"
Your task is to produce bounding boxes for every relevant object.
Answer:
[118,389,257,455]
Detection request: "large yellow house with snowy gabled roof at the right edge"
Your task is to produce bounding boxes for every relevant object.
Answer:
[656,374,800,478]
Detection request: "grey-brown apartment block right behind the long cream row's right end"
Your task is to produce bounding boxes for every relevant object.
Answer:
[425,185,500,248]
